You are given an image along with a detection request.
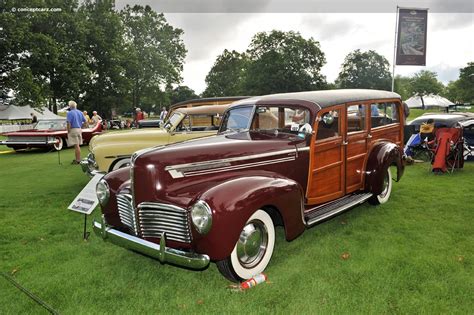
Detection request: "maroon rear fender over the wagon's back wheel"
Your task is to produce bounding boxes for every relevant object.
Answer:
[365,141,405,195]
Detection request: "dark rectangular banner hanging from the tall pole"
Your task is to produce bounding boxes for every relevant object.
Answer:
[396,8,428,66]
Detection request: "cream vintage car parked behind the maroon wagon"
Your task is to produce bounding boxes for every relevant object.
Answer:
[81,104,229,176]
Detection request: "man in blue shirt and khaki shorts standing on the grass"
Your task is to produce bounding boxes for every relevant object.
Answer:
[67,101,87,164]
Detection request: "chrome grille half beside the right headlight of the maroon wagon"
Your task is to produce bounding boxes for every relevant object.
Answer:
[138,202,191,243]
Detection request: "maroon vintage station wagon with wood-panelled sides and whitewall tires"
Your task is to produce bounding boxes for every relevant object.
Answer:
[93,90,404,281]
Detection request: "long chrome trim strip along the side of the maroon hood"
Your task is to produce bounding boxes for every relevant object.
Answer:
[165,149,297,178]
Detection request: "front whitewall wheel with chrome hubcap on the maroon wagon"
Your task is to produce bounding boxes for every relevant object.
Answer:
[217,210,275,282]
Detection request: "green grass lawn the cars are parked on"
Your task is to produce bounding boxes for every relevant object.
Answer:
[0,146,474,314]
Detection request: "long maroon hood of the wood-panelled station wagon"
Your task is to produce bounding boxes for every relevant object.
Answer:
[132,132,305,207]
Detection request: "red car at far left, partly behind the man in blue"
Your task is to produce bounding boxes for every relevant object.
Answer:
[0,119,102,151]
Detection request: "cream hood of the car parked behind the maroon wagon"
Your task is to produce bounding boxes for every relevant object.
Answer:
[89,128,168,151]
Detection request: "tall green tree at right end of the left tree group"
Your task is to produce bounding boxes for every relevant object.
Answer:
[120,5,186,111]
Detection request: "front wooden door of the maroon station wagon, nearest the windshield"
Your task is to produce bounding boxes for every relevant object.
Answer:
[306,105,345,205]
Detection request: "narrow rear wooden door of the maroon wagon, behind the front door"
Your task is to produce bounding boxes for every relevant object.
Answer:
[343,104,370,194]
